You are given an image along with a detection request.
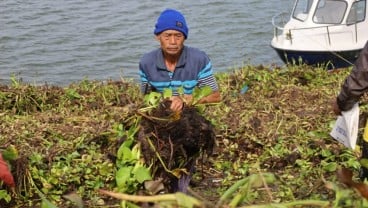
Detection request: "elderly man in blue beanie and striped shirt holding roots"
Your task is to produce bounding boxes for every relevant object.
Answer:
[139,9,221,111]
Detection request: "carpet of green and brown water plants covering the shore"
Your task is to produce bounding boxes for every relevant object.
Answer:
[0,66,367,207]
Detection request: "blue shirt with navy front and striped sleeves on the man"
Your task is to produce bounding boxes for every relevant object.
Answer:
[139,46,218,95]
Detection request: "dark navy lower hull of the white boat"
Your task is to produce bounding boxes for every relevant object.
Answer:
[274,48,362,69]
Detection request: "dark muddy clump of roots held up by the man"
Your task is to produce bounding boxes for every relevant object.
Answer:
[138,100,215,193]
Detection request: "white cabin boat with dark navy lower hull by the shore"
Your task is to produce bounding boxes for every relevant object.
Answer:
[271,0,368,69]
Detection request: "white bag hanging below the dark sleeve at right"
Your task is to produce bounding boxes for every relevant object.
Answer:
[330,103,359,150]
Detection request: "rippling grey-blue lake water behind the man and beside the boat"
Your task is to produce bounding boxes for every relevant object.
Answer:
[0,0,293,85]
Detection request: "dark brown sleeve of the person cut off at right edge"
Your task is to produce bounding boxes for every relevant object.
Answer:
[337,42,368,111]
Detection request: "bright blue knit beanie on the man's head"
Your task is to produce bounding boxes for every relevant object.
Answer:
[153,9,188,39]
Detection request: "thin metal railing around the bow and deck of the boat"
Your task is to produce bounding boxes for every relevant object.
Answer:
[272,12,358,45]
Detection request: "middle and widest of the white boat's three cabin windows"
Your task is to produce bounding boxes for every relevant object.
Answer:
[313,0,347,24]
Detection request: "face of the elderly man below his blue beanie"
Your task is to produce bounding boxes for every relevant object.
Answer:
[156,30,185,56]
